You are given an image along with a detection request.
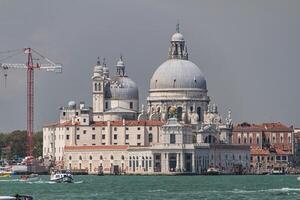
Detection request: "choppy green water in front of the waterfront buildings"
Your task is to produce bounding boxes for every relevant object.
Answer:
[0,176,300,200]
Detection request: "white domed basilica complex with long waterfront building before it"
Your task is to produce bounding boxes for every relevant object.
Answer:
[43,25,250,174]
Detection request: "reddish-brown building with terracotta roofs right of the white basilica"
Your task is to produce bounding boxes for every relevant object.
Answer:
[232,122,294,173]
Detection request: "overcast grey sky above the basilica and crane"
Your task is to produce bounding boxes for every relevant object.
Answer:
[0,0,300,132]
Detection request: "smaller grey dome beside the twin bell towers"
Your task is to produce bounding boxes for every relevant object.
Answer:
[110,76,139,100]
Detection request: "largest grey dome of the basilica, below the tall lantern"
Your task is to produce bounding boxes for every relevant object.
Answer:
[150,59,206,90]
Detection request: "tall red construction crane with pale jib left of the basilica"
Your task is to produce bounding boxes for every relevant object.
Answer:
[0,48,62,156]
